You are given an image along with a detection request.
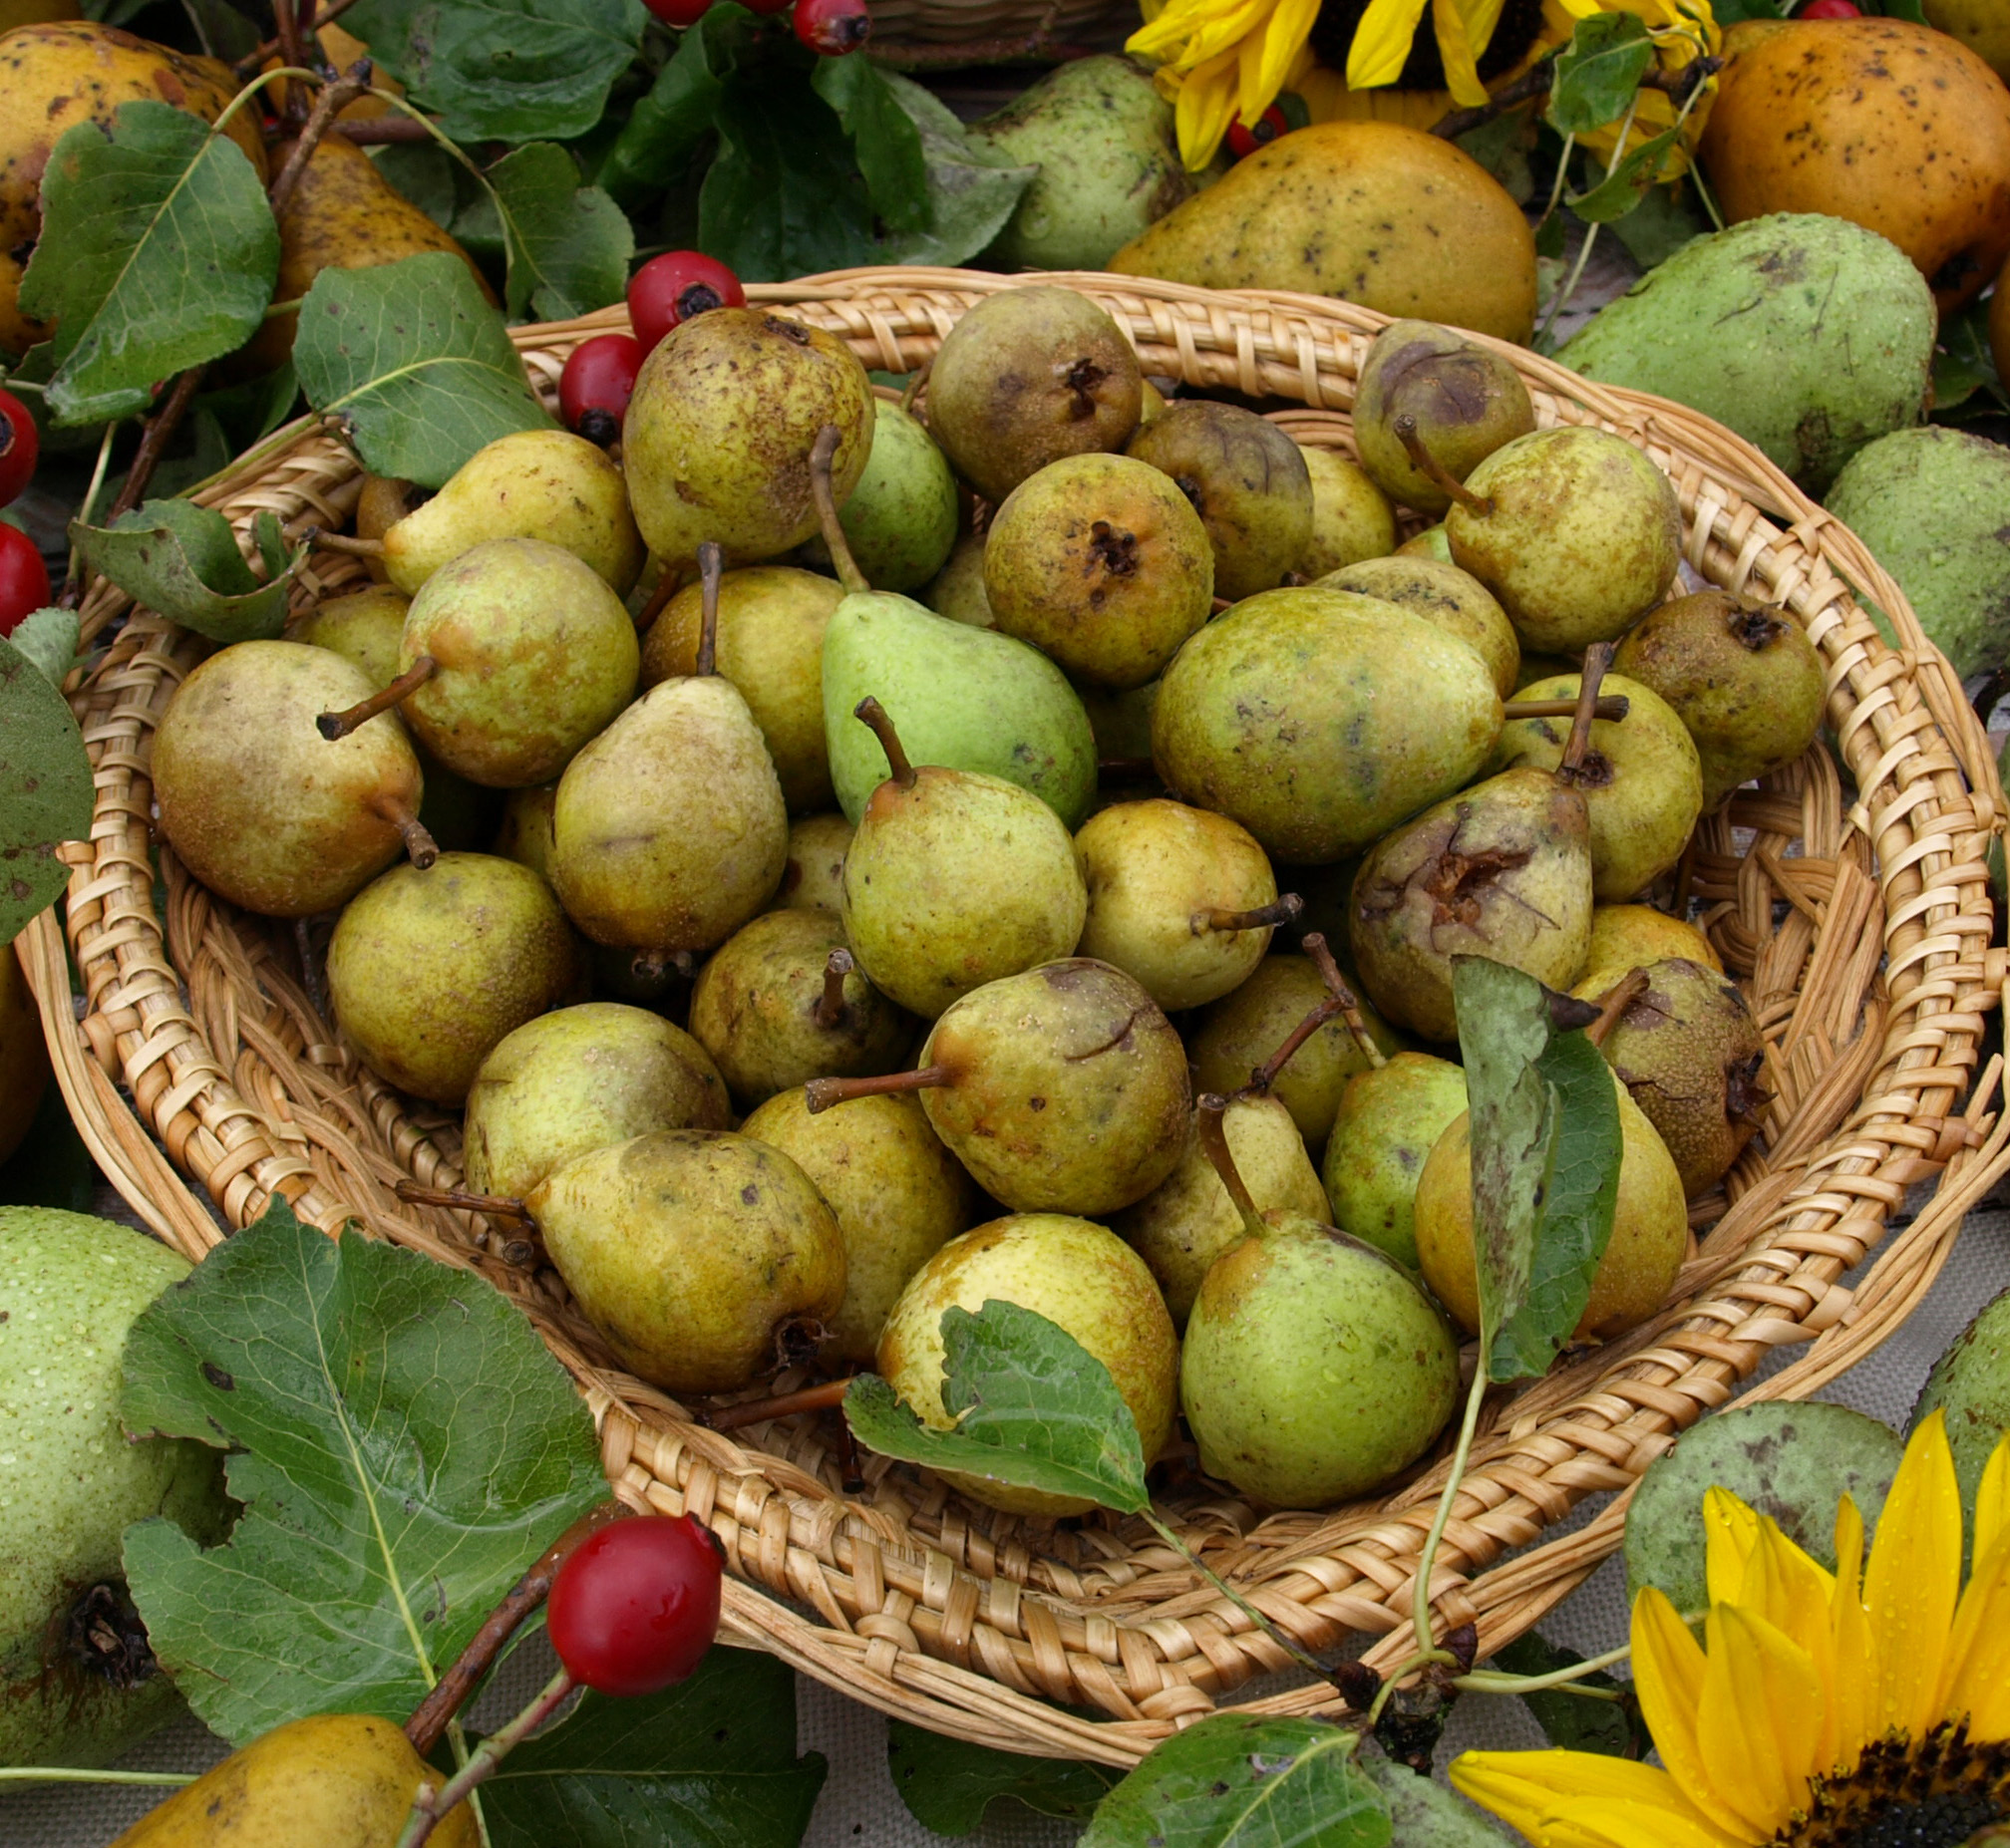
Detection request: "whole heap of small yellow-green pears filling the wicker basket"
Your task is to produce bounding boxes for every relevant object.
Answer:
[153,285,1826,1516]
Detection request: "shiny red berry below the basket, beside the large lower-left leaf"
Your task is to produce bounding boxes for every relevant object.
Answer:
[544,1514,720,1695]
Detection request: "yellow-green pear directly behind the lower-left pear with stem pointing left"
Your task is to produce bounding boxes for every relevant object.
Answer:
[461,1001,732,1199]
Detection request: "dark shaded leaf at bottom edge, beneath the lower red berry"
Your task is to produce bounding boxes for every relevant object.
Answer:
[483,1643,825,1848]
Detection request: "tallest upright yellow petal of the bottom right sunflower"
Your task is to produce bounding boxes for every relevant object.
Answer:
[1863,1412,1962,1739]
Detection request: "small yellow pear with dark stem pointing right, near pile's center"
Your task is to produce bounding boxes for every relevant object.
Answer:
[1076,799,1298,1015]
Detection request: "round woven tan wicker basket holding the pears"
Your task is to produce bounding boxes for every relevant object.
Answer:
[22,269,2006,1763]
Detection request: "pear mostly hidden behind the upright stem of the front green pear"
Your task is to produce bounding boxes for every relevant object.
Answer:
[1110,1092,1329,1328]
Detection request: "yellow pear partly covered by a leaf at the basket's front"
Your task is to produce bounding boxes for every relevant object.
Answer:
[878,1213,1179,1516]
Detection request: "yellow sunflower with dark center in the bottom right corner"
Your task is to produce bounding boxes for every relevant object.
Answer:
[1452,1412,2010,1848]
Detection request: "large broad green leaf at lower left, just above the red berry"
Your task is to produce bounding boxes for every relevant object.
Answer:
[123,1199,607,1743]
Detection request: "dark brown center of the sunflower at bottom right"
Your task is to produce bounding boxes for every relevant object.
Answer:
[1777,1725,2010,1848]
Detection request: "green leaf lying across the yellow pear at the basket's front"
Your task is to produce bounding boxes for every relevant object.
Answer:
[844,1298,1152,1514]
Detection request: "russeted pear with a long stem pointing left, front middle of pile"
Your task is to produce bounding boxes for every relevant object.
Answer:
[808,956,1191,1213]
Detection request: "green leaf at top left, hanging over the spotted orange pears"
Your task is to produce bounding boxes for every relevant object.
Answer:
[20,103,279,424]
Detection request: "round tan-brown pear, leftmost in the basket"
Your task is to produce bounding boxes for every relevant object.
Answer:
[153,641,438,918]
